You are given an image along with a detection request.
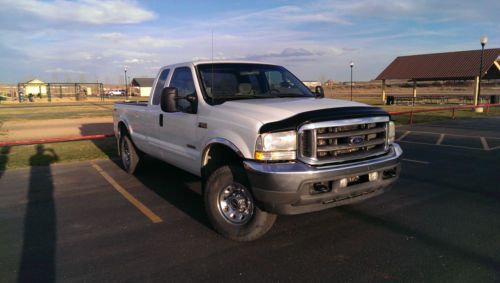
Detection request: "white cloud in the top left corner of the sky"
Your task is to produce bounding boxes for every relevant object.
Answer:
[0,0,156,25]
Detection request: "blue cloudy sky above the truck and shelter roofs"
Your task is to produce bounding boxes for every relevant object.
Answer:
[0,0,500,83]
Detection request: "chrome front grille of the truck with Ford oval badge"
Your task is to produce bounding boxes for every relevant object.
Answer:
[299,117,389,164]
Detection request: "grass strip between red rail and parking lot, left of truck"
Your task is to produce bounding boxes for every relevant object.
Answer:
[0,138,117,171]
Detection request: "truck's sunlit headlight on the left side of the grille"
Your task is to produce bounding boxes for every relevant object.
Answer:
[255,131,297,160]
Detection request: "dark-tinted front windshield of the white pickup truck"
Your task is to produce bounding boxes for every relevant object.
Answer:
[198,63,314,104]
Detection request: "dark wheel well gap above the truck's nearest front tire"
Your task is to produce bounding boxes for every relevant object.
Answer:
[201,143,243,180]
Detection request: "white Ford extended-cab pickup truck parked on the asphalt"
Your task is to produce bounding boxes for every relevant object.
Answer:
[113,61,402,241]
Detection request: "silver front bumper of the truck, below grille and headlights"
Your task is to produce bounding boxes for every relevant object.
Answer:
[243,144,403,214]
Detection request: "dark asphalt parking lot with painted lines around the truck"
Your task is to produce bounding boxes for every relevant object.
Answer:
[0,117,500,282]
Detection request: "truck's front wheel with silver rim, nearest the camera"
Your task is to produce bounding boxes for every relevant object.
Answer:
[203,165,276,242]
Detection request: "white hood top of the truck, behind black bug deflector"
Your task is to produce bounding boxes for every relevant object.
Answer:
[216,97,369,124]
